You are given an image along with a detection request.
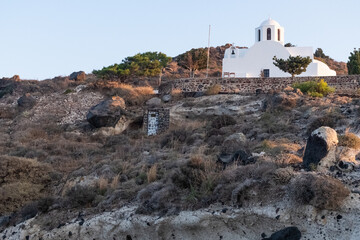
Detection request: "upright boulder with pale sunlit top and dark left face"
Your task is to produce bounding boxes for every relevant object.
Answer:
[303,127,339,171]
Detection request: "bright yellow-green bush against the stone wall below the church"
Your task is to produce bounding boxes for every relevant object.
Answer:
[293,79,335,97]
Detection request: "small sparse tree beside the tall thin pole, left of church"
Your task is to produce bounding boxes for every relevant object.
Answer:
[176,48,207,77]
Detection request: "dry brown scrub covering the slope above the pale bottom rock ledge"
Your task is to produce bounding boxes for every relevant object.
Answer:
[0,72,358,236]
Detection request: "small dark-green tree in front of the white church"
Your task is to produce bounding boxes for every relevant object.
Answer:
[273,56,312,77]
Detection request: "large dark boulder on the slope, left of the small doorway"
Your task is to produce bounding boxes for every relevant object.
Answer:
[86,97,125,128]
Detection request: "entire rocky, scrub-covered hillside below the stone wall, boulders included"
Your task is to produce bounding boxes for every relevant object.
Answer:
[0,73,360,240]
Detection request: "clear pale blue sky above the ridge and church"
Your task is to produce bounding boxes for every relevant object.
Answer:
[0,0,360,80]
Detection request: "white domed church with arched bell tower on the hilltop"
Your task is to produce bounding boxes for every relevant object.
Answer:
[222,18,336,78]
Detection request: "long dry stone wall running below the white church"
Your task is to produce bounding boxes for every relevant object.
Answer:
[173,75,360,93]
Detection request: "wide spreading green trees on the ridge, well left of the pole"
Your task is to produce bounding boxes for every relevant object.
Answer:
[93,52,171,80]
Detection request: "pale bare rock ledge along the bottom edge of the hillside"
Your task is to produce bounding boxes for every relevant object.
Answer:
[0,203,360,240]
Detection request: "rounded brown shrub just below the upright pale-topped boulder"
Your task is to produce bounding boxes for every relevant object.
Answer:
[289,174,350,210]
